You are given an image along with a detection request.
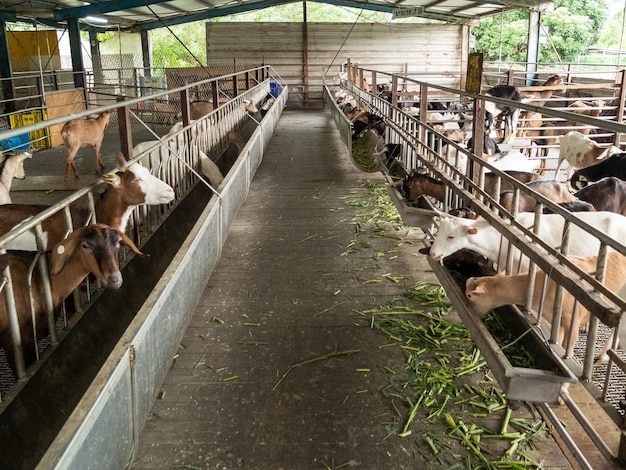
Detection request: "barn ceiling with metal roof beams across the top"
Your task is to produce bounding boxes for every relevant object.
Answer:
[0,0,552,31]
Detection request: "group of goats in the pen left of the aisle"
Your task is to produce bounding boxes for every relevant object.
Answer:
[0,93,264,377]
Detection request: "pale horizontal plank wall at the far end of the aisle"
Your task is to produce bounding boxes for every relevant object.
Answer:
[206,22,469,101]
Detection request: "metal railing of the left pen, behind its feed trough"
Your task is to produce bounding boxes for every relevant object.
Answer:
[0,66,280,404]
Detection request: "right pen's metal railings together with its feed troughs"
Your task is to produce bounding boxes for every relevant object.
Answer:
[325,66,626,468]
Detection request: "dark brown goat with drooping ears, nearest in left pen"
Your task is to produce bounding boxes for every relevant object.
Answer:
[0,224,143,375]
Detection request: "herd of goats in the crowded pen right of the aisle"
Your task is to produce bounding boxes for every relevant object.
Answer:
[335,75,626,378]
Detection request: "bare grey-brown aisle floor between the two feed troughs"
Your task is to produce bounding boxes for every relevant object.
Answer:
[133,110,571,470]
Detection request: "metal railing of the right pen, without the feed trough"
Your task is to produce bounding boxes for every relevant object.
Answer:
[342,65,626,466]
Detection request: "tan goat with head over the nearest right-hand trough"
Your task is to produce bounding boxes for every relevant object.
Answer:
[465,252,626,357]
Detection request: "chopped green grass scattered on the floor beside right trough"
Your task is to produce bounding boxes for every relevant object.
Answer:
[342,182,548,469]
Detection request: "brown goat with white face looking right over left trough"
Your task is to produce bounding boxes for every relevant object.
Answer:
[0,154,175,251]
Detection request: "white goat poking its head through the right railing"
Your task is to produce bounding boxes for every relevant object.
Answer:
[430,211,626,269]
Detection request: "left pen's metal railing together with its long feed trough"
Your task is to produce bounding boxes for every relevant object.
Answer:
[0,66,288,468]
